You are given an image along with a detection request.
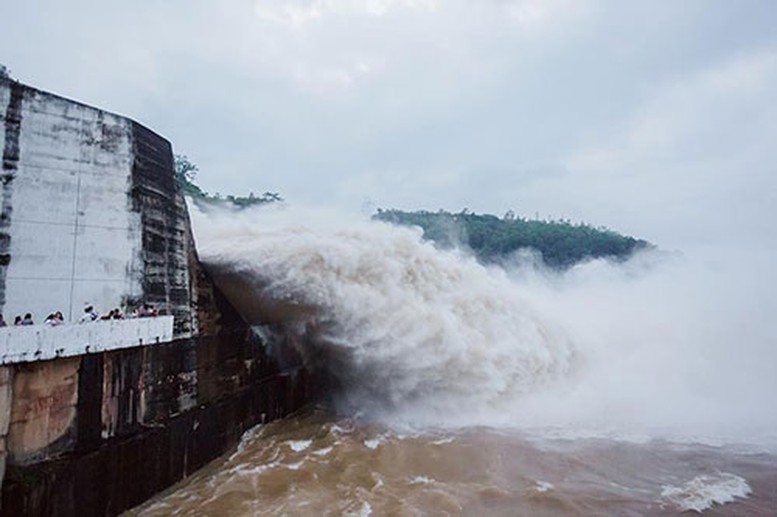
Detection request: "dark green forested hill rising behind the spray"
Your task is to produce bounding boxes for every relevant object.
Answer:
[373,209,652,269]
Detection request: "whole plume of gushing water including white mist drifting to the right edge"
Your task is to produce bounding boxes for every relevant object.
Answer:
[193,204,777,444]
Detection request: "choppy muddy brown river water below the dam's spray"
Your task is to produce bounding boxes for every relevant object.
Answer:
[129,410,777,517]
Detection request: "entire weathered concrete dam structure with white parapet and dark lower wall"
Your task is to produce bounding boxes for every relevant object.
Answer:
[0,77,312,515]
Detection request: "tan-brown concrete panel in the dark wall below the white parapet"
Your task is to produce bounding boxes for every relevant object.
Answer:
[8,358,81,464]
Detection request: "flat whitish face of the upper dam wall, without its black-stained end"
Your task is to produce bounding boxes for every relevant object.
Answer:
[0,74,143,322]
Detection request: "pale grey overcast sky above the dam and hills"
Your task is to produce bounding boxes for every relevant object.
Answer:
[0,0,777,249]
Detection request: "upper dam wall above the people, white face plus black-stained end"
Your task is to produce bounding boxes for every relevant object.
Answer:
[0,74,206,337]
